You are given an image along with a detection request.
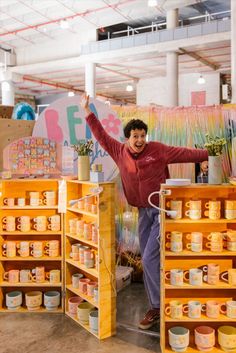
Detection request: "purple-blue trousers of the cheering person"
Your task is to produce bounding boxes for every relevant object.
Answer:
[138,207,160,308]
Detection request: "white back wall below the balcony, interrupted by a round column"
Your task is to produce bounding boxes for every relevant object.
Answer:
[137,72,220,106]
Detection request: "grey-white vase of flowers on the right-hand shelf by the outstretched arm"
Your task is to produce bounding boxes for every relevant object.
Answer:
[204,134,227,184]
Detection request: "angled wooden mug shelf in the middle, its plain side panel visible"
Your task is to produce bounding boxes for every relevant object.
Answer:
[65,180,116,339]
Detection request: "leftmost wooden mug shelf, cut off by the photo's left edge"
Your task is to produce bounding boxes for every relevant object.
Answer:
[0,179,64,313]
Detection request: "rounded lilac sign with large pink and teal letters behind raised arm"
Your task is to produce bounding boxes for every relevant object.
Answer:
[33,96,124,180]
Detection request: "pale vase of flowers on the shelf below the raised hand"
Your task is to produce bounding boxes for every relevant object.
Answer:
[72,140,93,180]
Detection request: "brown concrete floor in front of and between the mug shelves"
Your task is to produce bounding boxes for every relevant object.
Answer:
[0,283,160,353]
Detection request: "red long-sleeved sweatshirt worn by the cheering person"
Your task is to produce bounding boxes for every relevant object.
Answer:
[86,113,208,207]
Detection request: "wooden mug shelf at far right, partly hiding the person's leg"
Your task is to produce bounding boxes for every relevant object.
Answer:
[160,184,236,353]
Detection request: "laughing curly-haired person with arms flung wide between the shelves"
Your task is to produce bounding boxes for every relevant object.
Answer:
[81,95,208,330]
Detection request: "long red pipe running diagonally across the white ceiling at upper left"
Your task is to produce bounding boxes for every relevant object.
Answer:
[0,0,136,37]
